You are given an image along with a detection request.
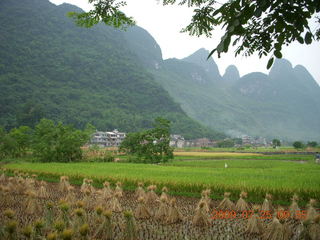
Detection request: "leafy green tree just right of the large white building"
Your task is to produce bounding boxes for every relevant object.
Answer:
[119,118,173,163]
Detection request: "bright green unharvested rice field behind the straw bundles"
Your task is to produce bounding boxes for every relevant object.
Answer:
[6,159,320,203]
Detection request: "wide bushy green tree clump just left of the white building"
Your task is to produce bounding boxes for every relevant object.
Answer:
[33,119,93,162]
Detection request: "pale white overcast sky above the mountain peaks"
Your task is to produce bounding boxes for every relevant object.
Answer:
[50,0,320,85]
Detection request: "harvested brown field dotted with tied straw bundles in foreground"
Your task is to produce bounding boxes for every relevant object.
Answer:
[0,169,320,240]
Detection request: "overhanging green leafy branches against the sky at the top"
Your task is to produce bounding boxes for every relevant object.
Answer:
[70,0,320,68]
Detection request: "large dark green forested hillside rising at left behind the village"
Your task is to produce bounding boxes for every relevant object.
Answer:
[0,0,223,138]
